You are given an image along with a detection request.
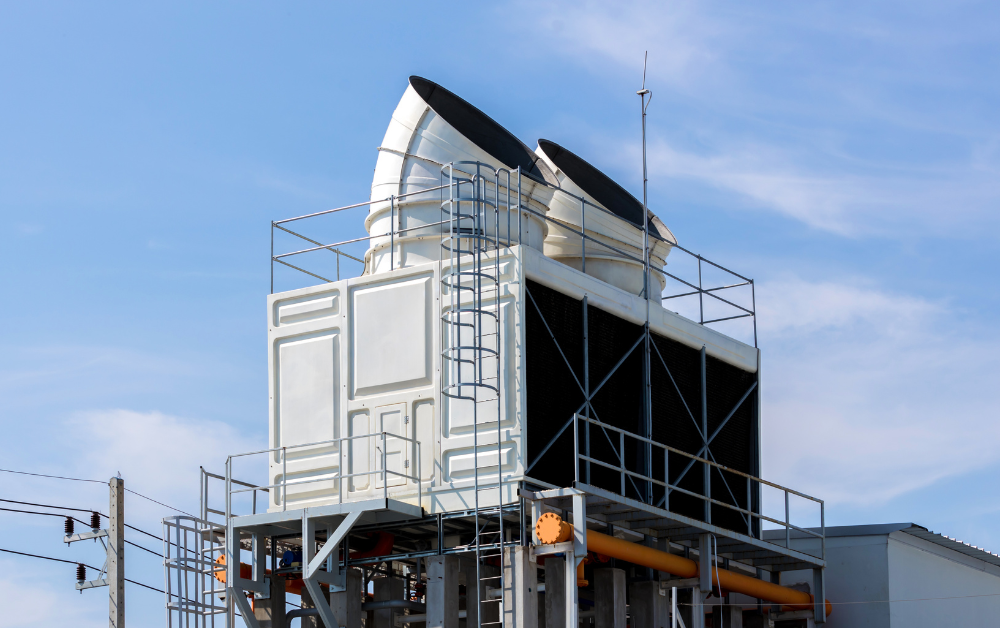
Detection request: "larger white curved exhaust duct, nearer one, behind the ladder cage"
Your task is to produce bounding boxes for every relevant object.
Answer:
[365,76,556,274]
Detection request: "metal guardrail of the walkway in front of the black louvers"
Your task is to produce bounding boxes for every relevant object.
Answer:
[572,414,826,560]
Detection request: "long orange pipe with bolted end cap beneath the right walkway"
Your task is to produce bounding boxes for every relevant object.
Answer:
[535,512,833,615]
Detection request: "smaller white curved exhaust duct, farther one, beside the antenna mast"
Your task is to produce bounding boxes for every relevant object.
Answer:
[535,140,677,294]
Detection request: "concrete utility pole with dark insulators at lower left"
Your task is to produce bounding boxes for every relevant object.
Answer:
[63,477,125,628]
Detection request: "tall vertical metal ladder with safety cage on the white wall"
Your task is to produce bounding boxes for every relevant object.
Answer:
[441,162,512,628]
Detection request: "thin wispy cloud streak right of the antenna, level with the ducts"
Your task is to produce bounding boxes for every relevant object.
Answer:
[626,138,1000,238]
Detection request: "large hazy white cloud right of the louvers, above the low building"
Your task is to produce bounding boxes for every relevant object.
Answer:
[759,278,1000,505]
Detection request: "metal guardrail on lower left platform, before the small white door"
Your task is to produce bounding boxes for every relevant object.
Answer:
[225,431,423,521]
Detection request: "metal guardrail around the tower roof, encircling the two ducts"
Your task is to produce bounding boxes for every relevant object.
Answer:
[271,162,757,347]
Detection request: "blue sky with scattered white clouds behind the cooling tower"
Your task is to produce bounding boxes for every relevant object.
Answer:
[0,2,1000,628]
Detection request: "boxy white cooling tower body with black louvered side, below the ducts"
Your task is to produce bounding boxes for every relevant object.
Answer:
[268,246,759,529]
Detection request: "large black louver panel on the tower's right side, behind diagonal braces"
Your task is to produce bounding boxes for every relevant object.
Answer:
[525,281,760,534]
